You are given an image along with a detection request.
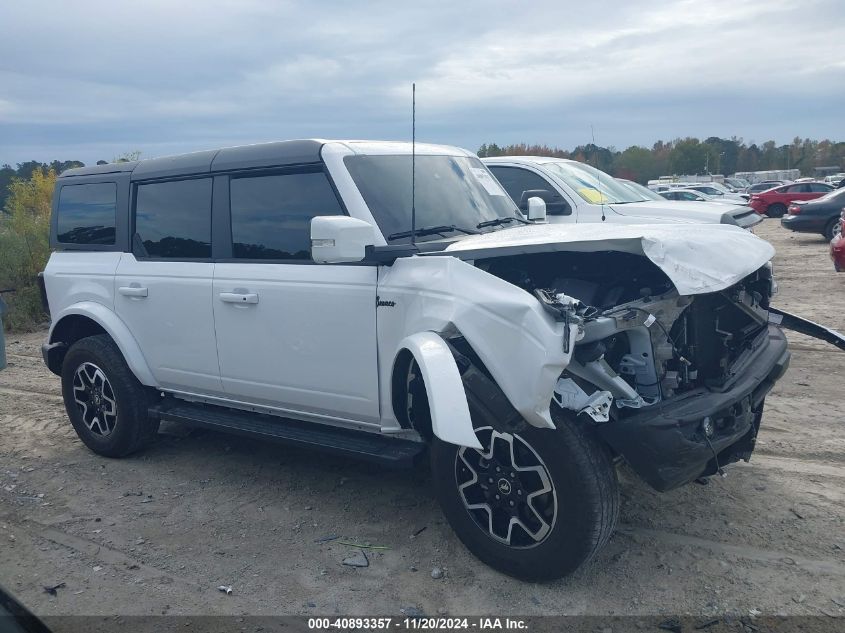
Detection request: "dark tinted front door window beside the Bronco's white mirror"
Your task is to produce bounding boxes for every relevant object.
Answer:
[229,172,343,259]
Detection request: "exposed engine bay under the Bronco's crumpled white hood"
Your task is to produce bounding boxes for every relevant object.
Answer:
[476,252,773,422]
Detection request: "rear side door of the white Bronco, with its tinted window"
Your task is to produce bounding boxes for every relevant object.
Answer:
[115,177,222,395]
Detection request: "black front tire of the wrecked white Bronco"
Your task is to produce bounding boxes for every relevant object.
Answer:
[431,411,619,582]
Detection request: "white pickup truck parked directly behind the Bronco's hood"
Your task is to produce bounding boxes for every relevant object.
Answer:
[482,156,762,229]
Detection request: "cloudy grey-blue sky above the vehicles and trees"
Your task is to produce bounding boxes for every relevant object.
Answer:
[0,0,845,165]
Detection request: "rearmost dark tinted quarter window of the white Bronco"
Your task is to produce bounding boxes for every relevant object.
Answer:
[56,182,117,244]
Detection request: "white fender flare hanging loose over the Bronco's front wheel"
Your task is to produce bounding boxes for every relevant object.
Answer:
[399,332,482,449]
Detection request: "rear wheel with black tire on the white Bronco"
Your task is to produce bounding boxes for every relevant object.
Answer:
[62,334,158,457]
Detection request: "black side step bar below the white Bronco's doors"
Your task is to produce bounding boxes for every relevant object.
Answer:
[150,400,426,468]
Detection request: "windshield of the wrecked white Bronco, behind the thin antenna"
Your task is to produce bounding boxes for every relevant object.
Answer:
[344,154,523,244]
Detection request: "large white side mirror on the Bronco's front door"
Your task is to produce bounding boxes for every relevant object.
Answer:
[311,215,375,264]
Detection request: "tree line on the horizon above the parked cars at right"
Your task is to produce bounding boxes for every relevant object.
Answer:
[478,136,845,184]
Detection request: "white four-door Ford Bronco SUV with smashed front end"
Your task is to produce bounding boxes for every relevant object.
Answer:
[43,140,789,580]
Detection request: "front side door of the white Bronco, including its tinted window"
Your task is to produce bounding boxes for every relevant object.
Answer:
[213,166,379,423]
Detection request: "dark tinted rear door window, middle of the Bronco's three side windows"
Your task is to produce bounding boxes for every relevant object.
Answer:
[135,178,211,259]
